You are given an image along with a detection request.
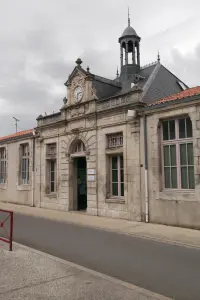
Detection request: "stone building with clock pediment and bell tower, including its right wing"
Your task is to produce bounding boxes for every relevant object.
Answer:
[0,18,200,227]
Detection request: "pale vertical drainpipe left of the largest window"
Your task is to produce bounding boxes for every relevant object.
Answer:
[144,115,149,223]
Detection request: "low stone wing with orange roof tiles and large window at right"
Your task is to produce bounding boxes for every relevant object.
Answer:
[141,87,200,228]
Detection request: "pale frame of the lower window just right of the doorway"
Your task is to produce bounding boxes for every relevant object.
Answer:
[109,153,124,198]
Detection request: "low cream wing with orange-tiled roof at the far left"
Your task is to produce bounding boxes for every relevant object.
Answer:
[0,130,34,206]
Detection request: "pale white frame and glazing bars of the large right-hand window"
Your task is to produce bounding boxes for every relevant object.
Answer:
[161,116,195,191]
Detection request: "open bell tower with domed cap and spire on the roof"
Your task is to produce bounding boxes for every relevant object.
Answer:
[119,10,141,81]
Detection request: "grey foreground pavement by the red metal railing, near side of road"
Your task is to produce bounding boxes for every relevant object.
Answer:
[0,242,170,300]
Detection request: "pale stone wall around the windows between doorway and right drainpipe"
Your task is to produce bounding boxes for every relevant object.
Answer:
[97,110,141,221]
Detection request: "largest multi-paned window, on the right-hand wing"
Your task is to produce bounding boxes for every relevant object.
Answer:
[162,118,195,189]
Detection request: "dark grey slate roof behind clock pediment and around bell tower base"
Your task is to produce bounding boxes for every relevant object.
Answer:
[65,58,188,104]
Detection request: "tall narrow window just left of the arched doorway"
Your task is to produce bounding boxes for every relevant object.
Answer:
[46,143,57,194]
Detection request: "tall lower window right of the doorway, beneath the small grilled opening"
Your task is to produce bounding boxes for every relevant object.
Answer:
[110,155,124,197]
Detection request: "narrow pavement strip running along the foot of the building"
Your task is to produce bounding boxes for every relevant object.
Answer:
[0,202,200,248]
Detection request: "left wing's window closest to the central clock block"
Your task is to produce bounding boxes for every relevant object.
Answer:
[20,144,30,184]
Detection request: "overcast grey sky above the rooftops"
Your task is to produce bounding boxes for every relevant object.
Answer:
[0,0,200,135]
